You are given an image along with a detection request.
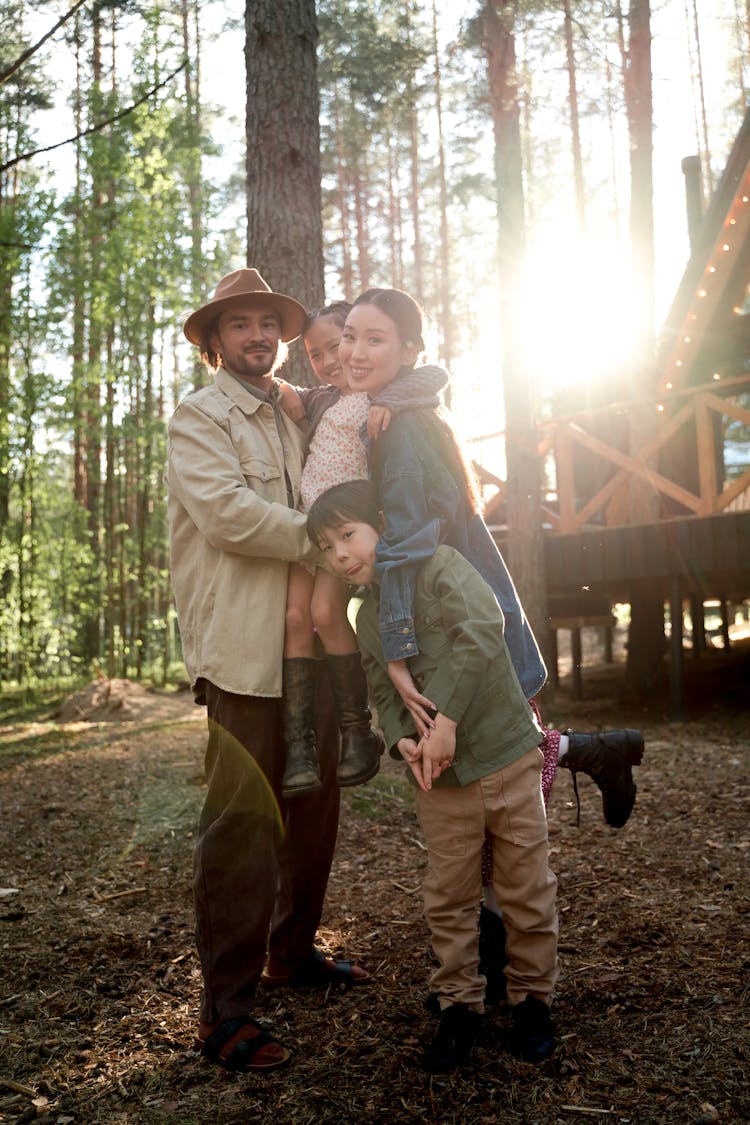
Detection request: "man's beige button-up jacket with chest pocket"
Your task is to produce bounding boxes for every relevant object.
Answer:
[166,370,317,696]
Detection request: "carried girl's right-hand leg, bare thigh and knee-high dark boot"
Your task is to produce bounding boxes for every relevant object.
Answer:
[313,570,386,785]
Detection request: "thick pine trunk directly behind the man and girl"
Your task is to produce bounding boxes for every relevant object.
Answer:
[245,0,325,383]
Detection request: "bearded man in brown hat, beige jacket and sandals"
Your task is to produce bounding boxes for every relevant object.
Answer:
[168,269,368,1071]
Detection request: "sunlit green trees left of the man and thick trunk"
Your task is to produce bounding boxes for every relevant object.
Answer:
[0,3,241,684]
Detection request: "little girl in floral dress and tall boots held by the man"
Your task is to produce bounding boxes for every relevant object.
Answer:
[279,302,448,798]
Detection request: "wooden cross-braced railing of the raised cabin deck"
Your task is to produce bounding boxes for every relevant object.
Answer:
[477,376,750,534]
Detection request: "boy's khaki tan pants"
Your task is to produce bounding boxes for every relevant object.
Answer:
[416,748,558,1011]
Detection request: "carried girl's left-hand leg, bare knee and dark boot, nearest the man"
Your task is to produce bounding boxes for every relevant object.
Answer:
[281,563,320,799]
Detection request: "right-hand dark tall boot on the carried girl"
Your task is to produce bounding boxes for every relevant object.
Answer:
[326,653,386,785]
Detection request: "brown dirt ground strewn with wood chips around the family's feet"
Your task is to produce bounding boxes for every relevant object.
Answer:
[0,653,750,1125]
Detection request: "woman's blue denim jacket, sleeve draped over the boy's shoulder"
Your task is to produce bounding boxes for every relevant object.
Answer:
[368,400,546,699]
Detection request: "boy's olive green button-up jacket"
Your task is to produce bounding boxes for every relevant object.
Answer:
[356,546,543,785]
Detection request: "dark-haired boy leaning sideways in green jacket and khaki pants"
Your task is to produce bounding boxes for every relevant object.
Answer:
[307,480,558,1072]
